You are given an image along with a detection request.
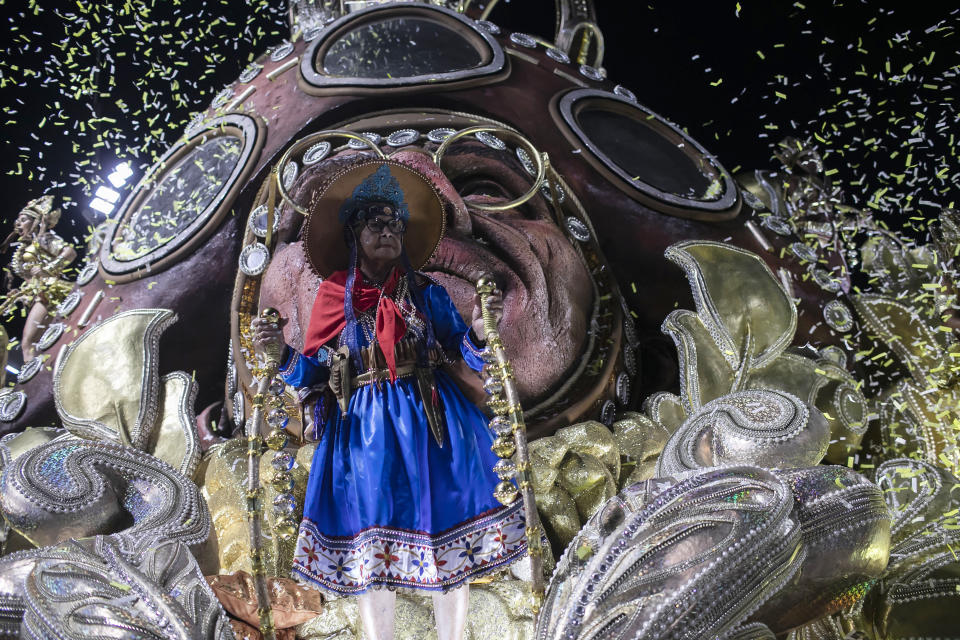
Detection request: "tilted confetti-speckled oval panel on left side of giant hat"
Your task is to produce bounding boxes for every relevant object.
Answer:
[100,114,264,279]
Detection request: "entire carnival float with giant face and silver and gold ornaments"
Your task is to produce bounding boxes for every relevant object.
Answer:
[0,0,960,640]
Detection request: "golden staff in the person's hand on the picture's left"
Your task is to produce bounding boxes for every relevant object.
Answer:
[247,306,283,640]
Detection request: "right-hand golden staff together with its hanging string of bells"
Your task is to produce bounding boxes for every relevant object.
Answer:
[477,276,544,613]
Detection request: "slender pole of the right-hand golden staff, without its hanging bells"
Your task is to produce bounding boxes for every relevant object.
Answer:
[477,276,544,613]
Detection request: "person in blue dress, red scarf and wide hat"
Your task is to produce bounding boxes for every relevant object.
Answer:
[253,161,526,640]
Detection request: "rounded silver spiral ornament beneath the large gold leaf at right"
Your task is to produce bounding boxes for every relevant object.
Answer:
[657,389,830,477]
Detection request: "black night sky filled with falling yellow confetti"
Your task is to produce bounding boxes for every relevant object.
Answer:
[0,0,960,245]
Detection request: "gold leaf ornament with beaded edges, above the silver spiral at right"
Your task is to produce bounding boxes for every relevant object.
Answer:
[645,241,868,464]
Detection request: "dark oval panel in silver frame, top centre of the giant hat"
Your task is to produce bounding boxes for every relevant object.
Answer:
[300,4,505,93]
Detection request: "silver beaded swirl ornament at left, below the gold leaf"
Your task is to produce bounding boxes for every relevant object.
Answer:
[0,439,210,546]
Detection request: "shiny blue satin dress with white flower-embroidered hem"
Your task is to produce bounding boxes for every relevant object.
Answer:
[281,284,526,594]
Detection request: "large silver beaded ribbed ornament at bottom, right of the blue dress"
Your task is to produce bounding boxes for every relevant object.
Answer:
[537,466,804,640]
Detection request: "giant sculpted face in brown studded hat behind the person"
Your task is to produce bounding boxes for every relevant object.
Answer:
[2,3,839,434]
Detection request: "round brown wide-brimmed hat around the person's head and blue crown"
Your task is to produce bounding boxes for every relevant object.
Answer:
[303,160,445,278]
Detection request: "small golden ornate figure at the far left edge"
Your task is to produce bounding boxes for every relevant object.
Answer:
[0,196,77,361]
